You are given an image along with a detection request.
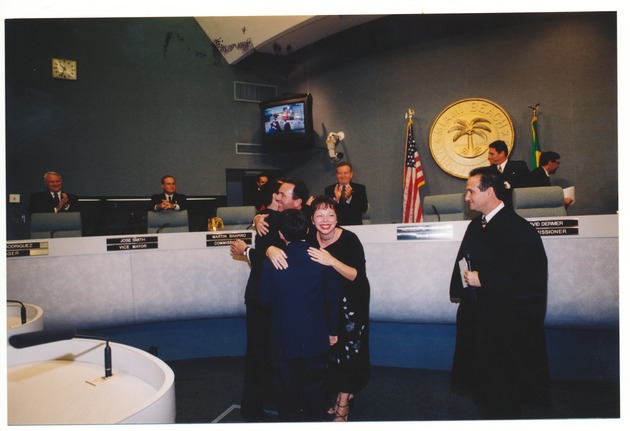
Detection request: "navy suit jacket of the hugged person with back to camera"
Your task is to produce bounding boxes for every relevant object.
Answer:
[260,241,341,360]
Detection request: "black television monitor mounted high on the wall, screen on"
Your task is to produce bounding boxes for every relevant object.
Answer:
[260,94,313,152]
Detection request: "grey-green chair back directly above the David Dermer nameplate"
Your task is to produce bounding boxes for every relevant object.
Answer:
[512,186,567,218]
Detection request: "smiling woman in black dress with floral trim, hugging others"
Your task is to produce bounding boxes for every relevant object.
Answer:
[309,196,370,422]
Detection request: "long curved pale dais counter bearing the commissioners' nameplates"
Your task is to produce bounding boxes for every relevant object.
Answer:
[7,215,619,328]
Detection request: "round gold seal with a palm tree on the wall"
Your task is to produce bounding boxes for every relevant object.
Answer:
[429,98,514,178]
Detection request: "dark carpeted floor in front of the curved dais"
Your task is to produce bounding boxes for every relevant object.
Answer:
[168,357,620,423]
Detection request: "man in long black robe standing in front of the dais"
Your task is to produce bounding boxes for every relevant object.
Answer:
[450,167,550,419]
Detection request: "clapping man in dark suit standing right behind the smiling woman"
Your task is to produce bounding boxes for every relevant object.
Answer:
[324,162,368,226]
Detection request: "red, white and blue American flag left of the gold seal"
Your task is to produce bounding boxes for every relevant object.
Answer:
[403,116,424,223]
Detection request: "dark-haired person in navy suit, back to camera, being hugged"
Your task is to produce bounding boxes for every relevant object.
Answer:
[260,209,340,421]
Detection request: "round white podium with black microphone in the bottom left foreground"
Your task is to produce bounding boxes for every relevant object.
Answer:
[7,338,175,425]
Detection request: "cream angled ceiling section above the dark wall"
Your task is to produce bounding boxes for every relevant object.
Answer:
[195,15,385,64]
